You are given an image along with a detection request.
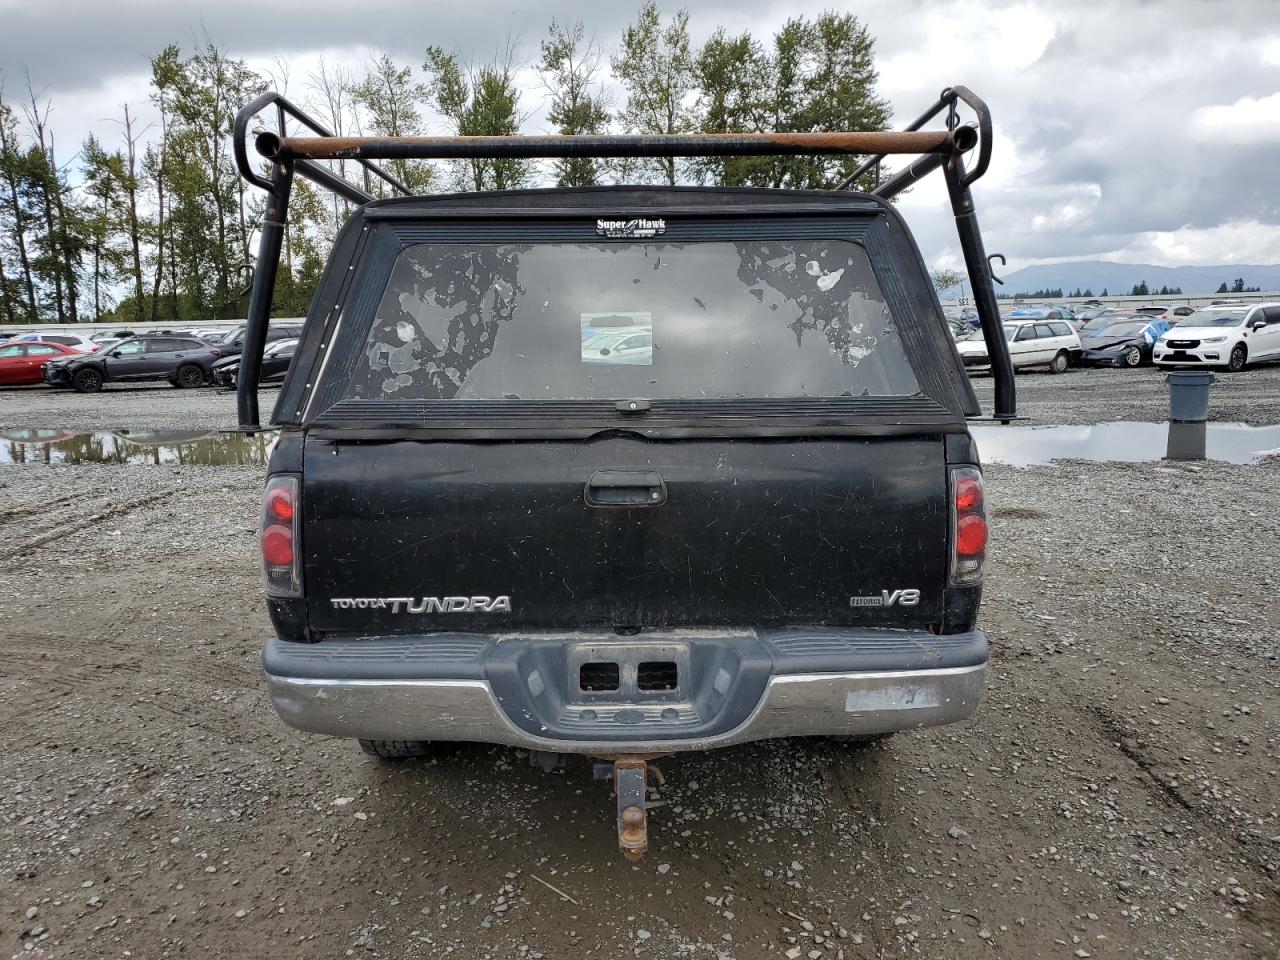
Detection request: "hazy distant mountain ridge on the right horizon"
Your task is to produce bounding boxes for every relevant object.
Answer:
[996,260,1280,297]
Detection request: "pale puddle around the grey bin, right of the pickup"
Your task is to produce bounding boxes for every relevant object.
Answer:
[969,420,1280,467]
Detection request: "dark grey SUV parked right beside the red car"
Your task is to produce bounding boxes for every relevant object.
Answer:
[44,337,221,393]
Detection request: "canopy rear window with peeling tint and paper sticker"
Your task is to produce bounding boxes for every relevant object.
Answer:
[343,239,919,401]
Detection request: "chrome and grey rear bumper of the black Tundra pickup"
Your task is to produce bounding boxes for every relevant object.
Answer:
[264,630,987,754]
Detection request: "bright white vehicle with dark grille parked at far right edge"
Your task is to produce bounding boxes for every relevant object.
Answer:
[1152,303,1280,372]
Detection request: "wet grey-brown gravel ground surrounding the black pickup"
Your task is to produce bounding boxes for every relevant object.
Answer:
[0,367,1280,960]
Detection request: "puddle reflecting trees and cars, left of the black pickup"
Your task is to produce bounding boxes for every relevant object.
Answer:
[0,429,275,466]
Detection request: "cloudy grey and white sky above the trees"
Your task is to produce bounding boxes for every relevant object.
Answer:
[0,0,1280,269]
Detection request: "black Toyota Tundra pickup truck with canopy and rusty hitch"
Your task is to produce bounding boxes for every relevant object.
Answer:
[230,86,1012,856]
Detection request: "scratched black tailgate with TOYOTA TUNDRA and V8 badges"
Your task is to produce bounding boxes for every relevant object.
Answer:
[302,435,950,635]
